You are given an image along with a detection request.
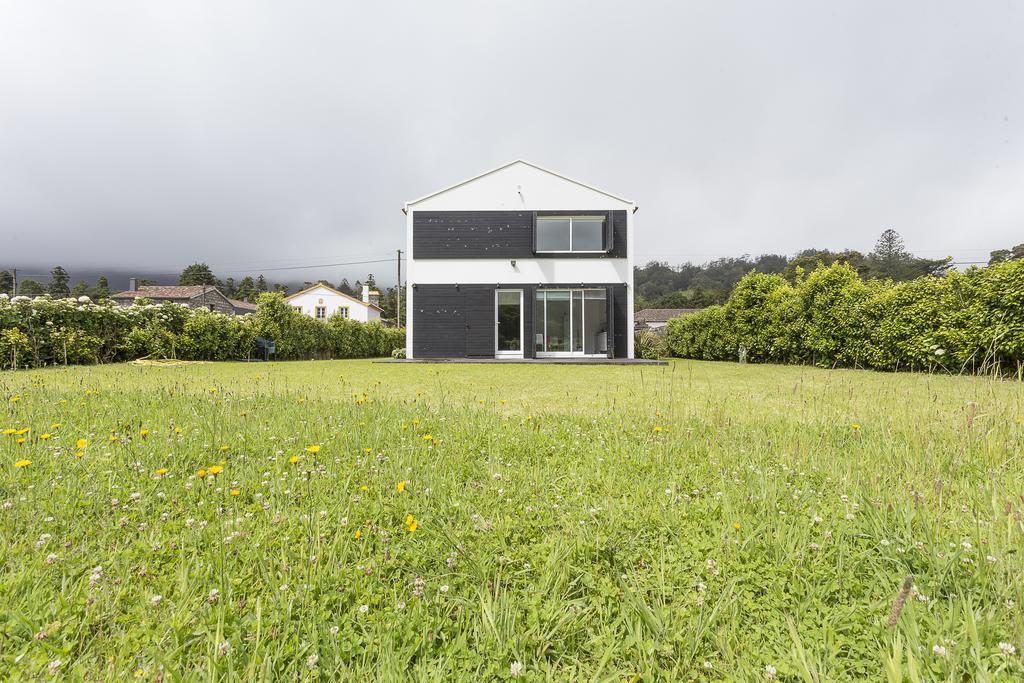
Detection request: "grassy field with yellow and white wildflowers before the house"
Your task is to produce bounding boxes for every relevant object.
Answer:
[0,361,1024,681]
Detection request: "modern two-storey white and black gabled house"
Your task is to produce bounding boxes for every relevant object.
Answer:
[402,160,637,358]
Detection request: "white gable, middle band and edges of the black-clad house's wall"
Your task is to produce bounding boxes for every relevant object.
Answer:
[406,161,637,358]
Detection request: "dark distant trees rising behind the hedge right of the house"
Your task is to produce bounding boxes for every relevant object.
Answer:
[634,229,1024,310]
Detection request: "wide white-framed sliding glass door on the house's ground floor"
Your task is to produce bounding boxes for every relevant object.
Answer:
[534,289,608,357]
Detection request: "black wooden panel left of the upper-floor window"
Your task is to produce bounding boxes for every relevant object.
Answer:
[413,211,534,258]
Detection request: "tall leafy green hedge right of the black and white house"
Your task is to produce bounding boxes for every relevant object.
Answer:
[668,261,1024,373]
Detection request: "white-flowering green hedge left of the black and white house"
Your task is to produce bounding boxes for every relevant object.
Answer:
[0,294,406,369]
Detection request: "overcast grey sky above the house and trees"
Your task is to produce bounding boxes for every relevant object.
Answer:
[0,0,1024,282]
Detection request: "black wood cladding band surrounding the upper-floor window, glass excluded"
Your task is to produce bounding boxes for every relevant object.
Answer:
[413,209,629,258]
